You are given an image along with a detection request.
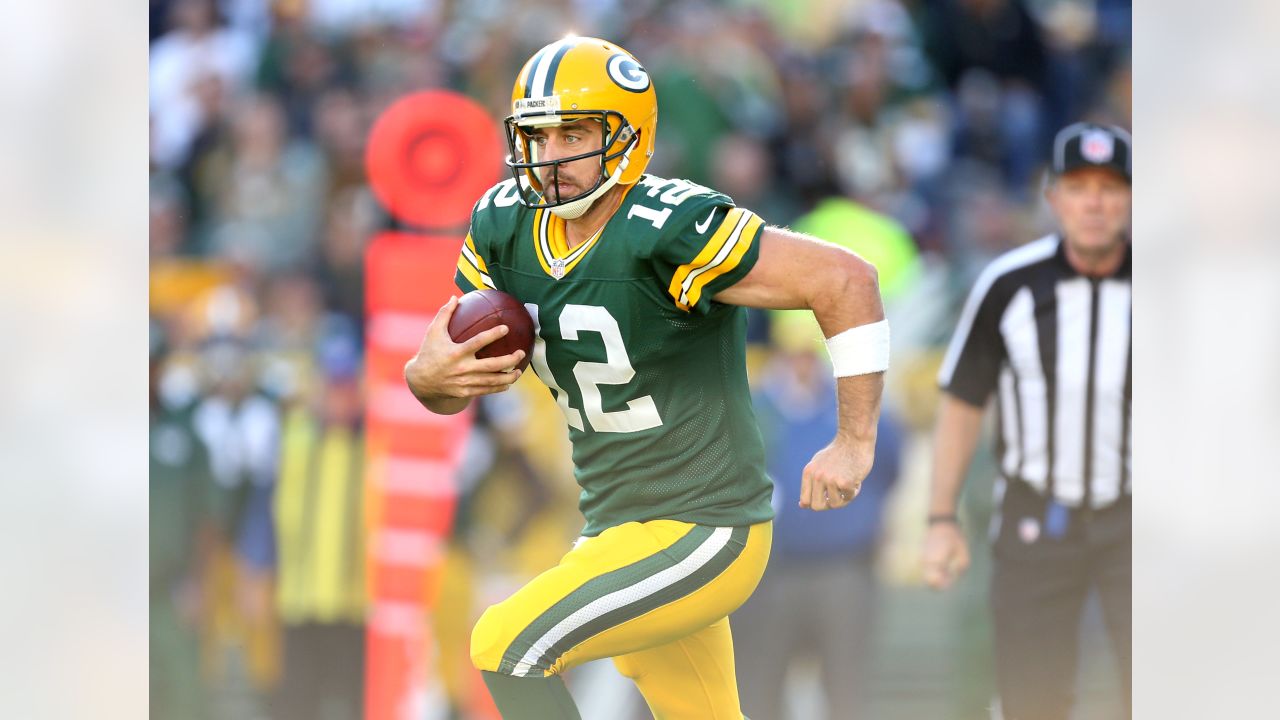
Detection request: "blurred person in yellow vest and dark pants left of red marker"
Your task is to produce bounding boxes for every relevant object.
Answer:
[274,334,367,720]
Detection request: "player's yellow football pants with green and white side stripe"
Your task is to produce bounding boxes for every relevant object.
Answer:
[471,520,773,720]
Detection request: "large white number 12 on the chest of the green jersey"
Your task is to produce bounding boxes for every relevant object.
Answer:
[525,302,662,433]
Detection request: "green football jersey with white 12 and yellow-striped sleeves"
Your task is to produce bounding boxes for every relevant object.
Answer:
[456,176,773,536]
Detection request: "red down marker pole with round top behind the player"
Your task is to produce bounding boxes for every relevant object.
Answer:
[365,91,502,720]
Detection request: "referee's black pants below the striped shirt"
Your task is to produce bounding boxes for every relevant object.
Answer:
[991,480,1133,720]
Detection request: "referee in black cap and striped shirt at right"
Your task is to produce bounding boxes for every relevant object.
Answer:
[924,123,1133,720]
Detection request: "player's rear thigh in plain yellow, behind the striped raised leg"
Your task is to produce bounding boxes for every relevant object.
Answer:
[613,618,742,720]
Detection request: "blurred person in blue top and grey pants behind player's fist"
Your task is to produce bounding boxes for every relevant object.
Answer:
[732,338,902,720]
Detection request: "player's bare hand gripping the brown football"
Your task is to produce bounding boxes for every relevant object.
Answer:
[404,297,525,413]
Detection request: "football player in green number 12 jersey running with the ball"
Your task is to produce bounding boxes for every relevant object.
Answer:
[404,37,888,720]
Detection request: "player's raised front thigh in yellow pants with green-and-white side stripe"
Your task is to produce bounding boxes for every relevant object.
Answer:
[471,520,771,675]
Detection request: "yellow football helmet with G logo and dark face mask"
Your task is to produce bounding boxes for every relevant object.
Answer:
[506,36,658,219]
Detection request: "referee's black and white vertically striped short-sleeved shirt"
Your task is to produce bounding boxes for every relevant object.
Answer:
[938,234,1133,507]
